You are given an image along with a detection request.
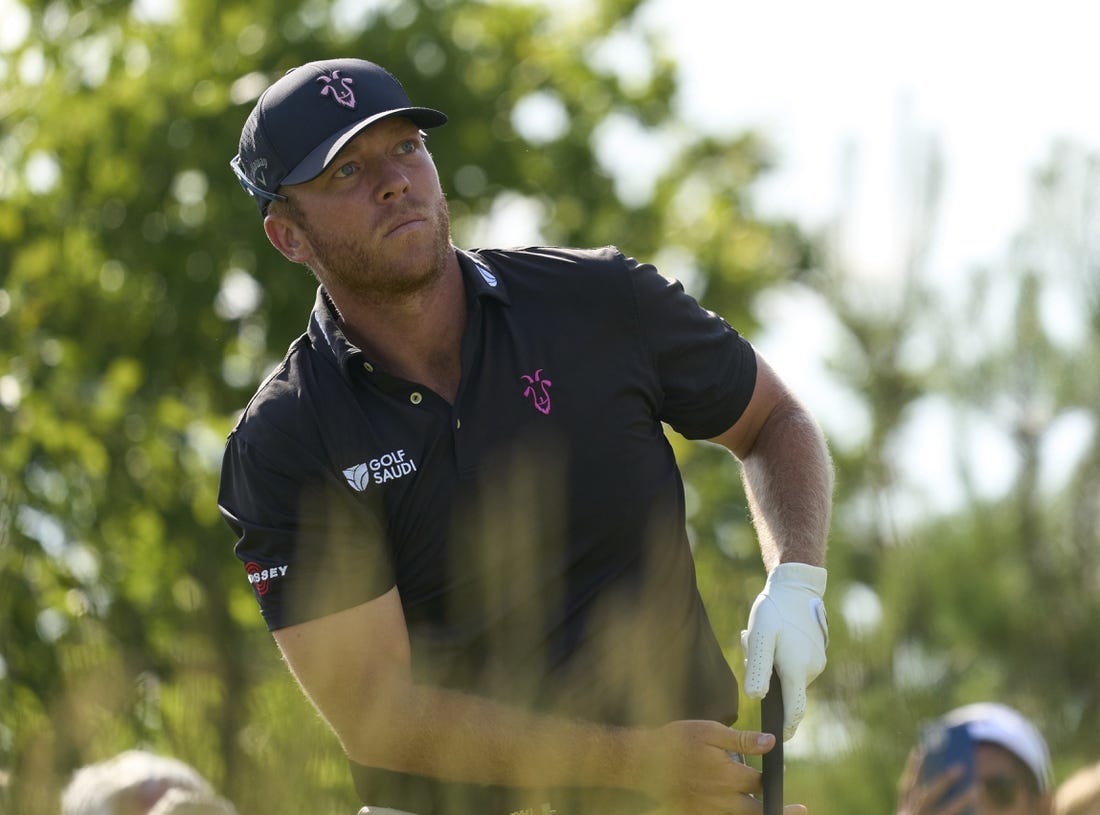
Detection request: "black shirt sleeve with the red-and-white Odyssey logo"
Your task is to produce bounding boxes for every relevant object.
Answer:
[218,427,394,630]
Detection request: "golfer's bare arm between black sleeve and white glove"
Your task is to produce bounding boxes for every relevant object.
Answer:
[711,354,833,572]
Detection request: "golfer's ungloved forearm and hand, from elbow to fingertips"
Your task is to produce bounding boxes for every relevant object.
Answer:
[325,682,774,812]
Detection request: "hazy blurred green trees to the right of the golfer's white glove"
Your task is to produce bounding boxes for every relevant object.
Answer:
[791,131,1100,813]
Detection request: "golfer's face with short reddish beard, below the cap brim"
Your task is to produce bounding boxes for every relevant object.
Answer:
[264,118,453,304]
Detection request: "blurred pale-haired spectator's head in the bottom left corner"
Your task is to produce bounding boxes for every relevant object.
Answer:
[62,750,237,815]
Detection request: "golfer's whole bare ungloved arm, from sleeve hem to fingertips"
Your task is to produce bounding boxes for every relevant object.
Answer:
[275,588,773,812]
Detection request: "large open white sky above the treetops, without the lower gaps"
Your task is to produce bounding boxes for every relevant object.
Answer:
[647,0,1100,274]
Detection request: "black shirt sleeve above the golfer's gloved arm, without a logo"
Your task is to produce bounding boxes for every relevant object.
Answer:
[626,252,757,439]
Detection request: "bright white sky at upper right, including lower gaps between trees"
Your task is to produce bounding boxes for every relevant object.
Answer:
[645,0,1100,516]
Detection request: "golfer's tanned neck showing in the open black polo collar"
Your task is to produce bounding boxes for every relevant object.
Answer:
[329,253,466,403]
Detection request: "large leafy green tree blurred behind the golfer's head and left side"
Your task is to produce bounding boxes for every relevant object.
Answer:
[0,0,805,815]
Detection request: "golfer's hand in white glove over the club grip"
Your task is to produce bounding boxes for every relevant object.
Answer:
[741,563,828,741]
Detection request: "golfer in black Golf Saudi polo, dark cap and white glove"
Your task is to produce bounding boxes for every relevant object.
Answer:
[219,59,832,815]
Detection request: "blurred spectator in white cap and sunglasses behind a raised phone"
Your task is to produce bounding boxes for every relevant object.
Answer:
[898,702,1054,815]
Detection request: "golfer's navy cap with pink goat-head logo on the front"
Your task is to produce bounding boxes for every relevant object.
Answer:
[230,59,447,214]
